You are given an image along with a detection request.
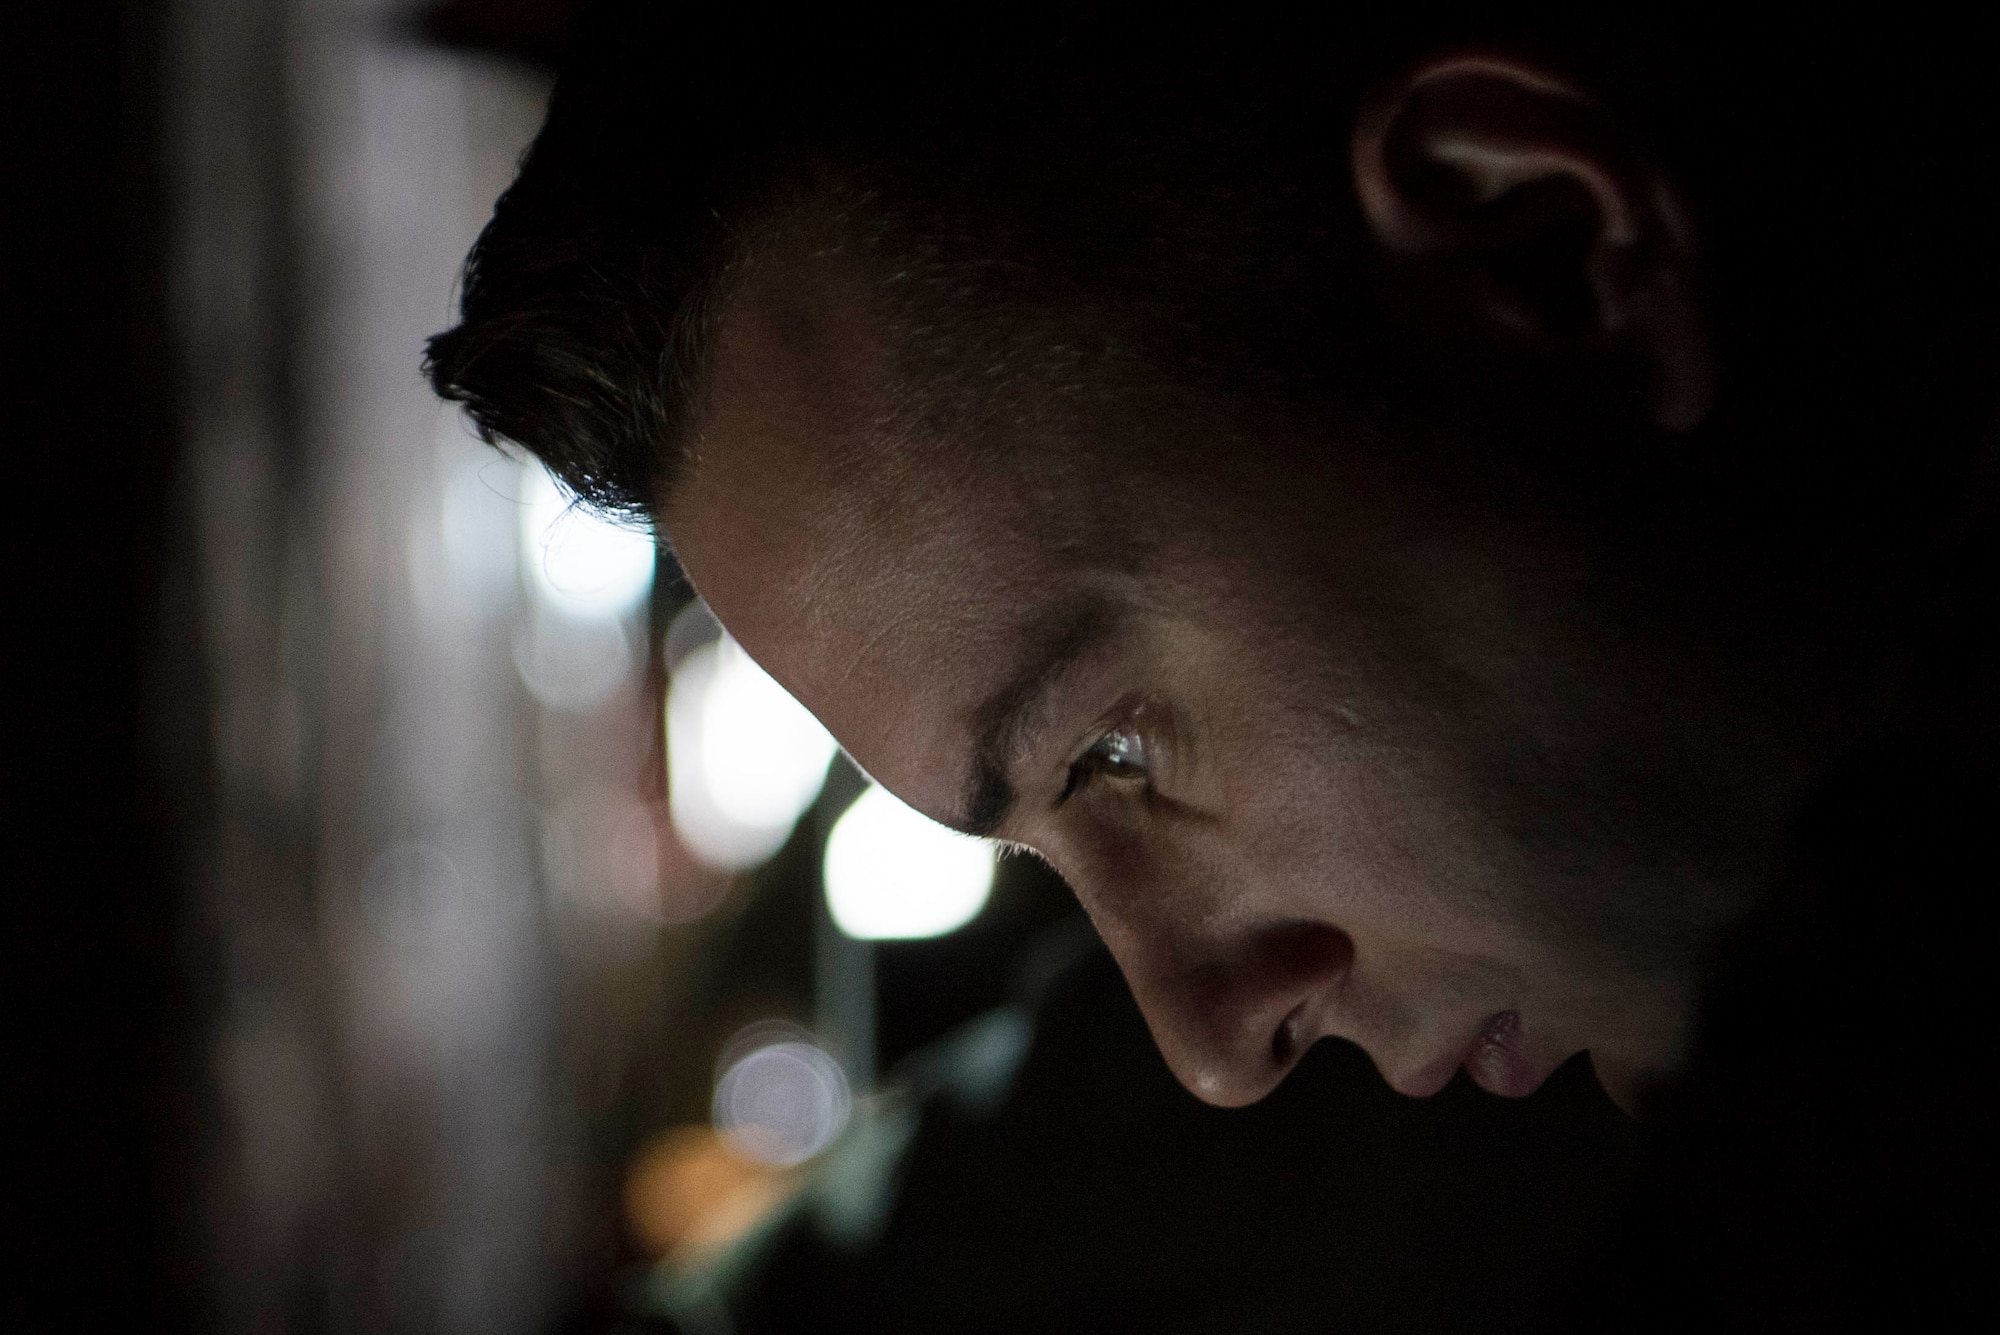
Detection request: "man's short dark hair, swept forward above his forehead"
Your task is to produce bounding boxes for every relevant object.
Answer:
[426,4,1552,518]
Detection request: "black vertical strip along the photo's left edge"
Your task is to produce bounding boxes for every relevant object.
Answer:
[0,0,192,1331]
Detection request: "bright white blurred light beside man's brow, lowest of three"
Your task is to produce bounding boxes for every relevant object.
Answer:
[826,783,996,941]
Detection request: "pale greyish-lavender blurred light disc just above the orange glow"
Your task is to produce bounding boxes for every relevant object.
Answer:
[712,1039,854,1167]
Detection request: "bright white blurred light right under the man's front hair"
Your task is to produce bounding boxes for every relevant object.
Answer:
[522,455,654,620]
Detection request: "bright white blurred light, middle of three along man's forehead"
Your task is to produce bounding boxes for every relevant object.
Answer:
[666,636,834,869]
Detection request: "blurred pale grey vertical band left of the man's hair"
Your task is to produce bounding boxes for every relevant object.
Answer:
[166,0,564,1335]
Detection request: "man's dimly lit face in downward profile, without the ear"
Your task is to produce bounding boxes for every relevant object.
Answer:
[666,244,1684,1103]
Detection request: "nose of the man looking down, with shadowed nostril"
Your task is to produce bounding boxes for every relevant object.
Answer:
[1106,921,1354,1107]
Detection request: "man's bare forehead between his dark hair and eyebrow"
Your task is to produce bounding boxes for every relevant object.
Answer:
[666,271,1062,815]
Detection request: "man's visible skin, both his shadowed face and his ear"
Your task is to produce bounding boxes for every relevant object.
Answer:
[664,56,1776,1105]
